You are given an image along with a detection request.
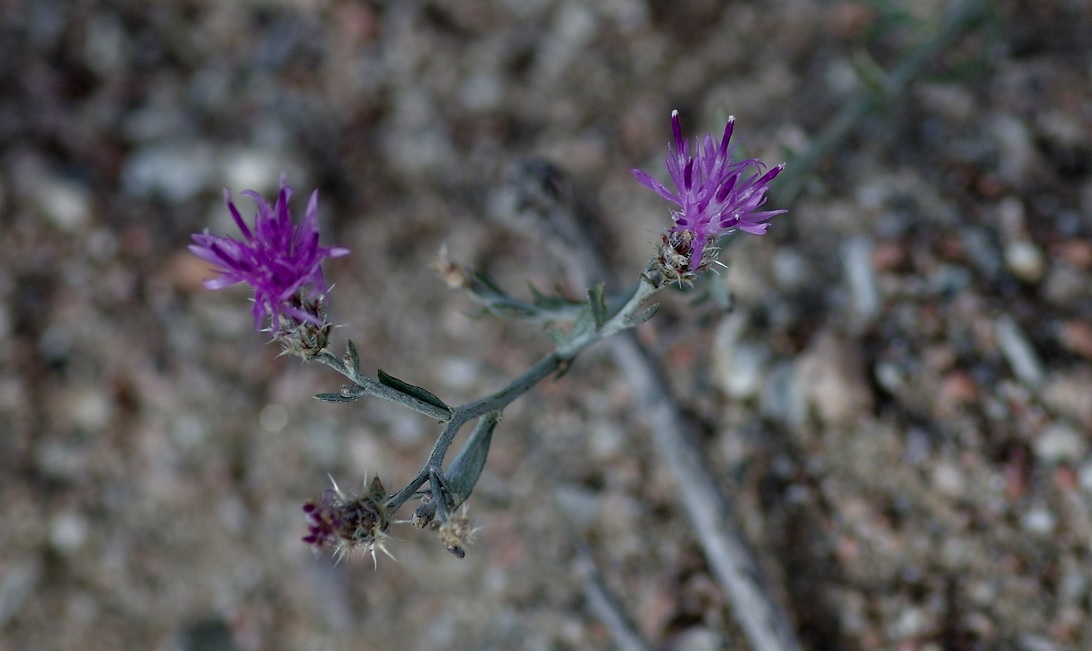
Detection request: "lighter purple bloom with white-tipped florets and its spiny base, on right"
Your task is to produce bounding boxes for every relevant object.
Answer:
[632,110,787,282]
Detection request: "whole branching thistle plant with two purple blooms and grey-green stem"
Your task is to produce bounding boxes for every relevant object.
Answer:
[190,111,785,560]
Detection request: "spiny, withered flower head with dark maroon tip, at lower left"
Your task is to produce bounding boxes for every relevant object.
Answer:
[302,477,394,565]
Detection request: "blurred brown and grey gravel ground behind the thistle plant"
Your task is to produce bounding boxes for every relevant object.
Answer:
[0,0,1092,651]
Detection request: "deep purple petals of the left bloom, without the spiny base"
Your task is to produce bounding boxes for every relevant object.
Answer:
[190,175,348,332]
